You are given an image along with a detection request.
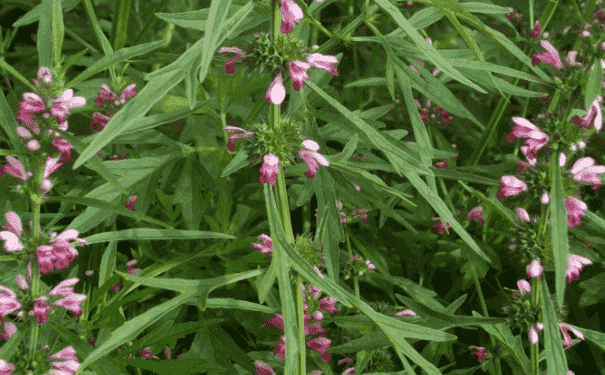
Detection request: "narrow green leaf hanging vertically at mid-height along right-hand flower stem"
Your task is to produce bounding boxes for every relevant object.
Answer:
[549,153,569,308]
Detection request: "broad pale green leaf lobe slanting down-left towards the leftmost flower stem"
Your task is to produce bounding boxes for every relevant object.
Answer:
[73,70,184,169]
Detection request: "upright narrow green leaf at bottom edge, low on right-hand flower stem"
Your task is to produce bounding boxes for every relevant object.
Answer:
[540,278,567,375]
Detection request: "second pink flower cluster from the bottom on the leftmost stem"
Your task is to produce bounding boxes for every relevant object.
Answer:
[0,275,86,324]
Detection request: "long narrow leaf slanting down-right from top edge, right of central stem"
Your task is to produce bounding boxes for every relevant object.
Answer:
[375,0,486,94]
